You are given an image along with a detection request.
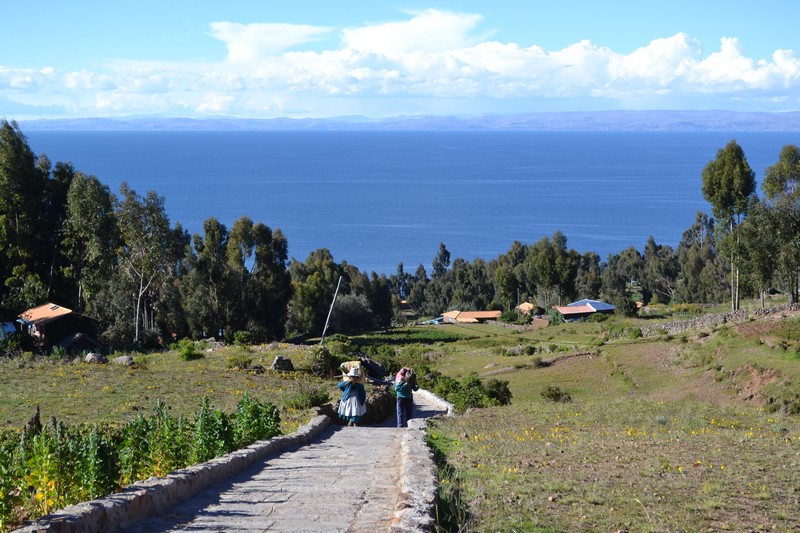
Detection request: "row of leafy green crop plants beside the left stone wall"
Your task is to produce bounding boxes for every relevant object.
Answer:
[0,393,280,531]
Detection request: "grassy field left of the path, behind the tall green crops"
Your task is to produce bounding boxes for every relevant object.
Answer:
[0,345,338,432]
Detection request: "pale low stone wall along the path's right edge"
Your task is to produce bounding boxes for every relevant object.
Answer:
[392,389,453,533]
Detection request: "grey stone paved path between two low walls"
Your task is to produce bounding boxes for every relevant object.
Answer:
[124,395,450,533]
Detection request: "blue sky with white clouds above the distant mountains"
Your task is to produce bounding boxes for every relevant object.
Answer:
[0,0,800,120]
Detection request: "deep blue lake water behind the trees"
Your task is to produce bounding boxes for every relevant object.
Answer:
[23,129,800,274]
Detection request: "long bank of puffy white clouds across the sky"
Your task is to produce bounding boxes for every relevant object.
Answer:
[0,10,800,117]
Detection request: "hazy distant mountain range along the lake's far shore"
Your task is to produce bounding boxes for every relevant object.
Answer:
[19,111,800,131]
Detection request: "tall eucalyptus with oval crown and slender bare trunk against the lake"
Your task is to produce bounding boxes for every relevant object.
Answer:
[702,140,756,311]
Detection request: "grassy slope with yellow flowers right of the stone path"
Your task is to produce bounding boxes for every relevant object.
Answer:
[424,308,800,531]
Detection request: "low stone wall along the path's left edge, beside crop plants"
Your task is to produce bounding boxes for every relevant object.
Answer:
[15,415,330,533]
